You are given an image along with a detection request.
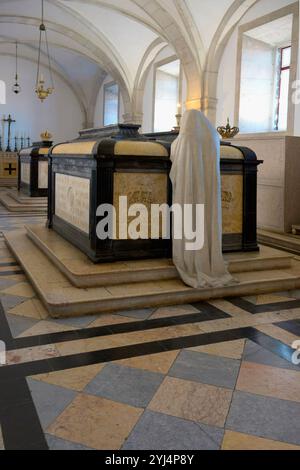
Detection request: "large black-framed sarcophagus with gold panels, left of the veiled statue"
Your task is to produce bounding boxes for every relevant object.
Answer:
[49,125,172,262]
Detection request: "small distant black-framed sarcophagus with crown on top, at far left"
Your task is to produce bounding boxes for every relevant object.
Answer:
[18,141,52,197]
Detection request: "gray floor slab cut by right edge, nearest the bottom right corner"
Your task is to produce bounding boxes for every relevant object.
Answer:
[226,392,300,445]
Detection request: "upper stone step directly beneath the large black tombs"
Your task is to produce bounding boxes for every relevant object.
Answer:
[25,225,293,288]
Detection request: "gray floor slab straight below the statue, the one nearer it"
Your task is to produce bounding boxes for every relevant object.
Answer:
[168,351,240,389]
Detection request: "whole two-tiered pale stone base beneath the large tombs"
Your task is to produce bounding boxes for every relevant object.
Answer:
[4,226,300,318]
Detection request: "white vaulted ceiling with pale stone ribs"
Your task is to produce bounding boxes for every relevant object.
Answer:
[0,0,292,121]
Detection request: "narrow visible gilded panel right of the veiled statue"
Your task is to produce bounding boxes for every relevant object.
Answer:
[222,175,243,234]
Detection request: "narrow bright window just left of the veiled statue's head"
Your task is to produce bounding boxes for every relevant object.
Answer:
[154,60,181,132]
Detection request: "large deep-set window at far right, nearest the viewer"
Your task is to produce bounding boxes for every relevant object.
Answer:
[239,14,294,133]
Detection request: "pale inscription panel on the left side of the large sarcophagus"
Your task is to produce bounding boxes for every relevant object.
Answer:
[55,173,90,233]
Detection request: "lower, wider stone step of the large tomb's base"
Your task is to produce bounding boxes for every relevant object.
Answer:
[4,230,300,318]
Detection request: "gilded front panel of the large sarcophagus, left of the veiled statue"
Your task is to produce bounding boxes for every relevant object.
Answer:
[114,173,168,239]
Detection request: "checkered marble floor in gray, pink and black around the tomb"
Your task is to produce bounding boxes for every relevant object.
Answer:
[0,208,300,450]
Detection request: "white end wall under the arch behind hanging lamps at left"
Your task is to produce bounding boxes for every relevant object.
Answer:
[0,56,84,142]
